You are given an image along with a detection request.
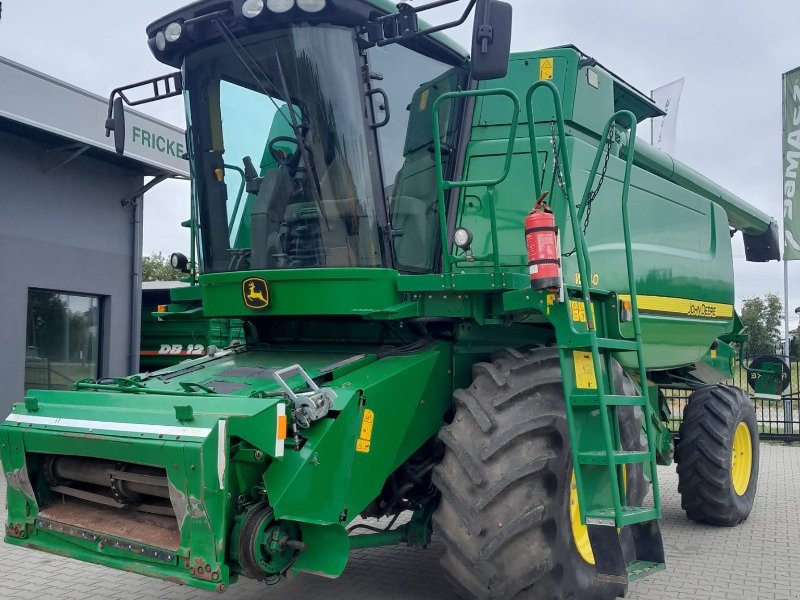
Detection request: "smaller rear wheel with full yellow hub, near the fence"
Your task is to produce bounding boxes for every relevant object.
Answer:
[675,385,759,527]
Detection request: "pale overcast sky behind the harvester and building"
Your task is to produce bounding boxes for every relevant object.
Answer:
[0,0,800,327]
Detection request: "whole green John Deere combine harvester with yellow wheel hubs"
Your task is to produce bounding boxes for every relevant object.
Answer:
[0,0,779,600]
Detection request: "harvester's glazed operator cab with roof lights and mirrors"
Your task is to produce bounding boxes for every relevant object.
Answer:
[124,0,510,273]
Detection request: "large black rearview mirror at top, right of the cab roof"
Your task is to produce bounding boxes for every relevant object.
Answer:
[472,0,512,81]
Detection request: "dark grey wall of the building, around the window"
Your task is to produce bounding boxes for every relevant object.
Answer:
[0,131,143,413]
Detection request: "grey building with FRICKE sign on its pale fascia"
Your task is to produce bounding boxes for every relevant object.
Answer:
[0,58,188,414]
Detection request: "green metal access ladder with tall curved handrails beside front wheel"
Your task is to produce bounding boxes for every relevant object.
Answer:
[526,81,664,585]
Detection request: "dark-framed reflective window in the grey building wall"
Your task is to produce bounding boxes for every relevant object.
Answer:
[25,290,102,390]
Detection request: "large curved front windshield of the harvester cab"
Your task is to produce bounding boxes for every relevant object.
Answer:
[185,27,383,272]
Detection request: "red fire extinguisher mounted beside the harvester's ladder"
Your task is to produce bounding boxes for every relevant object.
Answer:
[525,192,561,291]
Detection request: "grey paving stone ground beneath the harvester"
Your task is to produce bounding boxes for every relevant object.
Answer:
[0,444,800,600]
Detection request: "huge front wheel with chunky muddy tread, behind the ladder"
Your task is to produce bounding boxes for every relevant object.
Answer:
[434,348,648,600]
